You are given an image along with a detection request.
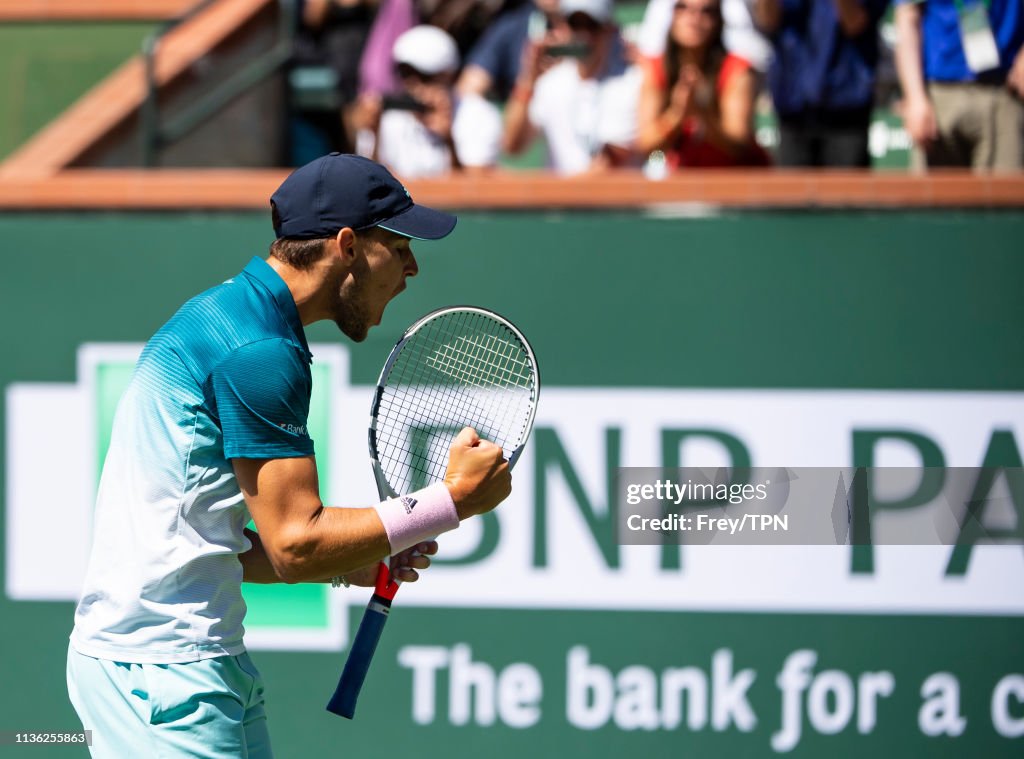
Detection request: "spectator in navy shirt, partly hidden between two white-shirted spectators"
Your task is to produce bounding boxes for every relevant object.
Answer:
[458,0,565,102]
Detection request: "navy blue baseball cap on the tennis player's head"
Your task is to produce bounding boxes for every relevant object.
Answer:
[270,153,458,240]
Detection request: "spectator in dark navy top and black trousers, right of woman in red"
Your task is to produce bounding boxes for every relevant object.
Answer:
[755,0,889,167]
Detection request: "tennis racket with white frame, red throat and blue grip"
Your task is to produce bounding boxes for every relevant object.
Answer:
[327,306,541,719]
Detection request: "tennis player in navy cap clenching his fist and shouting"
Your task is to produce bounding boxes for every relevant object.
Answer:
[68,154,511,759]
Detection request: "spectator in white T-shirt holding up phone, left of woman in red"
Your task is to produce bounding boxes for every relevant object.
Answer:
[504,0,640,174]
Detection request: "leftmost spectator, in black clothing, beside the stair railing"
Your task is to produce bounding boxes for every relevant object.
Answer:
[287,0,377,166]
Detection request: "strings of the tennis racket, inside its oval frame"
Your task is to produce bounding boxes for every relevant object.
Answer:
[377,311,537,493]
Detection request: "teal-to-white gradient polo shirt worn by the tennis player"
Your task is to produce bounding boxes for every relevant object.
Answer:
[72,258,313,664]
